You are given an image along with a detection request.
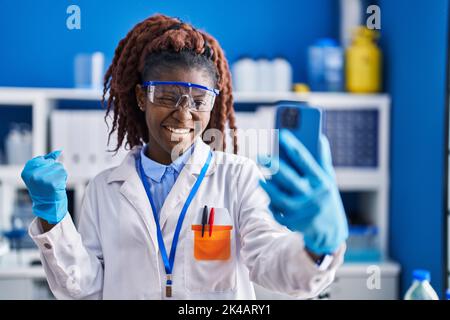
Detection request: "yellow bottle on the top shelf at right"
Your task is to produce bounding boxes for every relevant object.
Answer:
[345,26,382,93]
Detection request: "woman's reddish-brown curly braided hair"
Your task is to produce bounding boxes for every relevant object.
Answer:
[102,14,237,153]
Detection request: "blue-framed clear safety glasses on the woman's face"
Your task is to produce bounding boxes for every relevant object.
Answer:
[142,81,219,112]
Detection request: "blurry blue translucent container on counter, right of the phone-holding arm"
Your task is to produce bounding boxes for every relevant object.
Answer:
[345,225,382,262]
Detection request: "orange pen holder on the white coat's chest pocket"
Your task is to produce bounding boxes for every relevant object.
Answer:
[192,225,233,260]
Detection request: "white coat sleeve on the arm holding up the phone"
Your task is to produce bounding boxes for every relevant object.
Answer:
[237,160,345,298]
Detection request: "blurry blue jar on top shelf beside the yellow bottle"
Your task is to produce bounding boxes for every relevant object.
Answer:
[308,38,344,91]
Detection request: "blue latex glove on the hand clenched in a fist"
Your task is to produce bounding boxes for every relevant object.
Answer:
[21,150,67,224]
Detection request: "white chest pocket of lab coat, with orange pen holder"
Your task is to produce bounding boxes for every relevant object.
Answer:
[185,208,237,293]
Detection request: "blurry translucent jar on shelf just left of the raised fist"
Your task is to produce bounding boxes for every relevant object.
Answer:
[5,123,33,165]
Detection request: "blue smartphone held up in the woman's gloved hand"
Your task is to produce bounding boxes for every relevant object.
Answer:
[275,101,322,168]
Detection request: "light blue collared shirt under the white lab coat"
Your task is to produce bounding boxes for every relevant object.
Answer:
[137,145,194,217]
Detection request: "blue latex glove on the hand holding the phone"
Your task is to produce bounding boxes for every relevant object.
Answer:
[259,129,348,255]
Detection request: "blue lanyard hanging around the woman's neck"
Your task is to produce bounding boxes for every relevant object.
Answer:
[138,151,212,275]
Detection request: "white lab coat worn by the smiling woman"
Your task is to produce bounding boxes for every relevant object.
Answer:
[29,139,345,299]
